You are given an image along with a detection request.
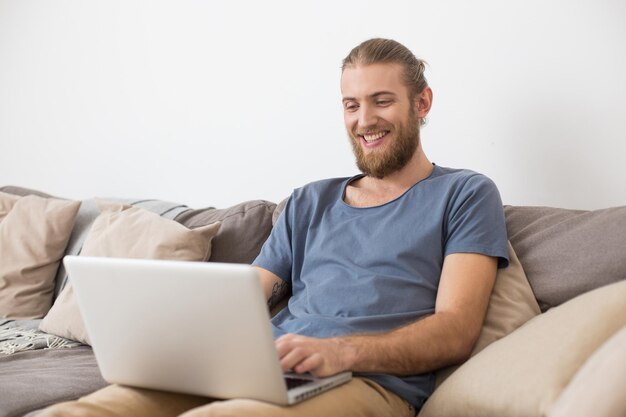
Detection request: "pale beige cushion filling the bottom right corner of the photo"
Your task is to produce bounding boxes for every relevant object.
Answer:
[548,327,626,417]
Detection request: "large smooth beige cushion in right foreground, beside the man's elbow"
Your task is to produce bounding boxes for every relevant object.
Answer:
[420,281,626,417]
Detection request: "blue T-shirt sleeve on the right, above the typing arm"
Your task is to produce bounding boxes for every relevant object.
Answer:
[444,174,509,268]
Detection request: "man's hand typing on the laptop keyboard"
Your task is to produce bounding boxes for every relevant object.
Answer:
[276,334,354,377]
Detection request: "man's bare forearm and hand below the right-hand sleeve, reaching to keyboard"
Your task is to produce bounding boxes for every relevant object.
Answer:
[276,253,497,377]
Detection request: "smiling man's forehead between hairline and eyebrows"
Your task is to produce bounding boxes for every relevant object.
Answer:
[341,64,408,99]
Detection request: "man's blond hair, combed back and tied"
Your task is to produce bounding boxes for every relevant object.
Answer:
[341,38,428,101]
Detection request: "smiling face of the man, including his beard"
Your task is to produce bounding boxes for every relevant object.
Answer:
[341,64,419,178]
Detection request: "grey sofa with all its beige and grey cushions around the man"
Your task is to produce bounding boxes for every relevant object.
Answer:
[0,186,626,417]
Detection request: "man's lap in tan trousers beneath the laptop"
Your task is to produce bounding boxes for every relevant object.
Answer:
[38,378,415,417]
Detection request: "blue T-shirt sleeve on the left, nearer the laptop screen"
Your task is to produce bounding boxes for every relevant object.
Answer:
[252,195,294,282]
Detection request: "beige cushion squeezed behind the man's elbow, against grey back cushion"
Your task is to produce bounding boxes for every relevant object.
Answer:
[437,243,540,386]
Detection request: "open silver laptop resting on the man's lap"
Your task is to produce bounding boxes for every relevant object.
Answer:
[64,256,352,405]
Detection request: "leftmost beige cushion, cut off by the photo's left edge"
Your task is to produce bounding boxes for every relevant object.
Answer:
[0,192,80,319]
